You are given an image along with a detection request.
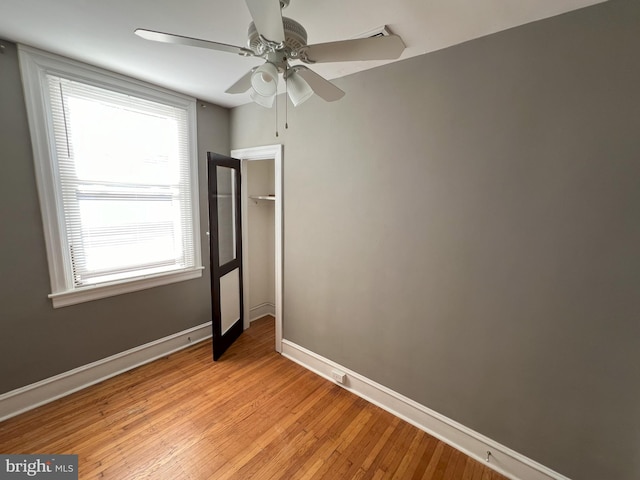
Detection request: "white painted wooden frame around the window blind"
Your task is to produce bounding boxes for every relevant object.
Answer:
[18,45,204,308]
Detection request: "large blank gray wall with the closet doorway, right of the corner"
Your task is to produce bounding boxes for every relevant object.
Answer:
[231,0,640,480]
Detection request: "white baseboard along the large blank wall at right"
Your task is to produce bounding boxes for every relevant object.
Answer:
[282,340,569,480]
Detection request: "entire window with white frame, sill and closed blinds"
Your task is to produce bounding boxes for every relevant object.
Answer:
[20,46,202,307]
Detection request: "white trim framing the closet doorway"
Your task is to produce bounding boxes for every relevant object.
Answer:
[231,144,284,353]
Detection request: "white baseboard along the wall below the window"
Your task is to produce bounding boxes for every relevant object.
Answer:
[0,322,211,422]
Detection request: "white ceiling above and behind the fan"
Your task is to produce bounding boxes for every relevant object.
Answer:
[0,0,602,107]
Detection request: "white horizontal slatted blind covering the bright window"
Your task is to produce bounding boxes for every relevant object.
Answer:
[47,75,194,286]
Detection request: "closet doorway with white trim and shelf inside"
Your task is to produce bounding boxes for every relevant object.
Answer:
[231,145,283,352]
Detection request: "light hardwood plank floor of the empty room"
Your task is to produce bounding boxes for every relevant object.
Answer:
[0,317,506,480]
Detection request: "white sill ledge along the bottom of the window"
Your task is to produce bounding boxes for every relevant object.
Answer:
[49,267,204,308]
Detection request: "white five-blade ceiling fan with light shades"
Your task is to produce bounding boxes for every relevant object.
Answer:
[135,0,405,108]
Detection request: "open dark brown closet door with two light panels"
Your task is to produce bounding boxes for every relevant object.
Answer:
[207,152,244,360]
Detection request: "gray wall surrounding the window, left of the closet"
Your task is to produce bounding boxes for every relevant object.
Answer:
[0,42,229,393]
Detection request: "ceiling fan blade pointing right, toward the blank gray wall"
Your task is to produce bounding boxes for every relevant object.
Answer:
[301,35,405,63]
